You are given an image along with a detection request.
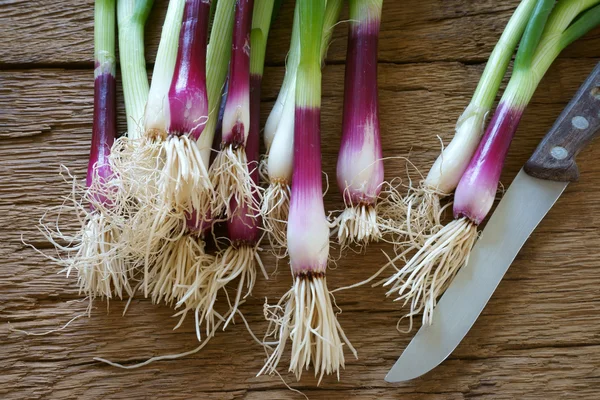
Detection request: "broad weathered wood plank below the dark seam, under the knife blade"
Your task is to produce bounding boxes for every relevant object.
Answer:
[0,60,600,399]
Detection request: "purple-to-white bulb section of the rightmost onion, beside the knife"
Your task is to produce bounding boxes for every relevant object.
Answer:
[454,103,523,225]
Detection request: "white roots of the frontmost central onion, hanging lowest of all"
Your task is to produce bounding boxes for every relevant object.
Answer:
[257,276,358,383]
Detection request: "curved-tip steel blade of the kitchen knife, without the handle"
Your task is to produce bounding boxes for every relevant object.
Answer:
[385,170,568,382]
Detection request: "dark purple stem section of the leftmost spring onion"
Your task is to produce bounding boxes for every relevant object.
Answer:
[86,68,117,204]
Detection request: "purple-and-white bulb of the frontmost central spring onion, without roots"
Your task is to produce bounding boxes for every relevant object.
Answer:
[287,107,329,276]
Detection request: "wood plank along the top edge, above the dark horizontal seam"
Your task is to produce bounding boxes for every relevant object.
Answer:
[0,0,600,66]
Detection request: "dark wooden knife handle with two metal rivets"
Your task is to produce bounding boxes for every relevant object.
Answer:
[524,63,600,182]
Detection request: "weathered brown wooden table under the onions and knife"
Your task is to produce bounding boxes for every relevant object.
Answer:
[0,0,600,399]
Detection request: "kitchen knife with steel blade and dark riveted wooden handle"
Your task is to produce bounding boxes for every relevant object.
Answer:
[385,63,600,382]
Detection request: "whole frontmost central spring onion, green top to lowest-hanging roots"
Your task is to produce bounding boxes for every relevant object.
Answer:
[259,0,356,381]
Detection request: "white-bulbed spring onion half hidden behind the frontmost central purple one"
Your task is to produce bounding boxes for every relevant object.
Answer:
[261,0,343,249]
